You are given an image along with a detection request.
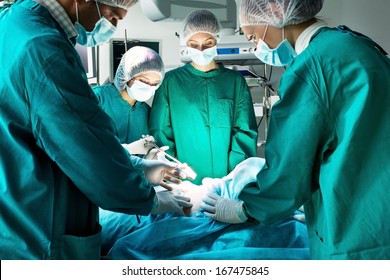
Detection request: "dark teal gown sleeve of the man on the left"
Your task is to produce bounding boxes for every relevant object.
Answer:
[27,47,155,214]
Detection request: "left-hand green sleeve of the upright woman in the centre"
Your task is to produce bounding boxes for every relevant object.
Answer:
[149,78,176,157]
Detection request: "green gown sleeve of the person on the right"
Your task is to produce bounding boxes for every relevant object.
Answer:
[239,75,332,223]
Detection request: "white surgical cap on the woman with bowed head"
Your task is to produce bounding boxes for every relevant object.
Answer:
[114,46,164,90]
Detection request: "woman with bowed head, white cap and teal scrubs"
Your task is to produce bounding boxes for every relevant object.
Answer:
[93,46,164,143]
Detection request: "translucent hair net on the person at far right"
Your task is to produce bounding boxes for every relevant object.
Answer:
[240,0,324,27]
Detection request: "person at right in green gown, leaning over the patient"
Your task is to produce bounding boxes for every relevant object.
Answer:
[201,0,390,259]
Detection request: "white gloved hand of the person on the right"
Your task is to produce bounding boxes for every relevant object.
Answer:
[201,193,248,224]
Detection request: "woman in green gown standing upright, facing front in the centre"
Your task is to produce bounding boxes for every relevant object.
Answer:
[150,10,257,184]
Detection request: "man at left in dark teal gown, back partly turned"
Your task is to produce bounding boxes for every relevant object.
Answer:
[0,0,191,259]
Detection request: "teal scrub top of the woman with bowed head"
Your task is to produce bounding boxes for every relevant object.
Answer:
[93,84,150,144]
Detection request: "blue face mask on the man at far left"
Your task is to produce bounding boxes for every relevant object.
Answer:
[75,2,116,47]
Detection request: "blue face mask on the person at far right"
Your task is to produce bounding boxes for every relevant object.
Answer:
[254,26,297,66]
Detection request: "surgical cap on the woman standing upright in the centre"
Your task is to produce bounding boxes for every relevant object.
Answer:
[180,10,222,45]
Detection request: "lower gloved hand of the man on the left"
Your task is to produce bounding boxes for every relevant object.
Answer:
[151,191,192,216]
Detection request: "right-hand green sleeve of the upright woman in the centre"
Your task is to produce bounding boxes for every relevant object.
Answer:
[229,78,257,172]
